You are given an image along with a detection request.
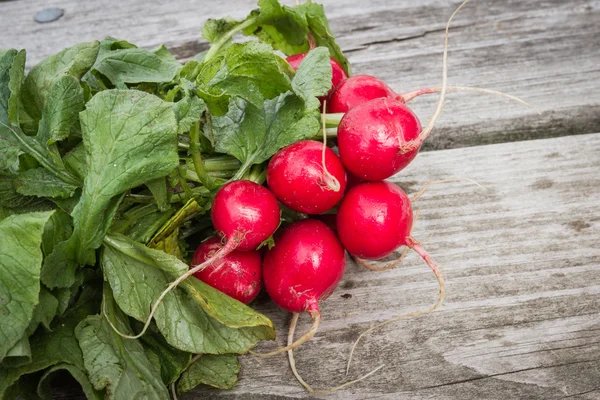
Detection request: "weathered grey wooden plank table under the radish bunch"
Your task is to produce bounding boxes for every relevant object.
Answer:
[0,0,600,400]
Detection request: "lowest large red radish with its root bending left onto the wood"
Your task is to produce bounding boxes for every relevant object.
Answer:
[253,219,346,356]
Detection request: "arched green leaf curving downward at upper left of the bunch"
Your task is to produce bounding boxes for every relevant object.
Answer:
[21,41,100,120]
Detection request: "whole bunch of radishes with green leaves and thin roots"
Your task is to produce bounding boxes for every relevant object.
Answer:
[0,0,536,400]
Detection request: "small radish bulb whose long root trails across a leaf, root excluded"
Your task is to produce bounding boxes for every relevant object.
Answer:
[211,180,280,251]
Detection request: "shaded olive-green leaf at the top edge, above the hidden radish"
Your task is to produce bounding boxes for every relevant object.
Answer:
[242,0,308,55]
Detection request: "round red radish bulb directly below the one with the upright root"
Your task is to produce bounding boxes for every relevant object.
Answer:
[337,182,413,260]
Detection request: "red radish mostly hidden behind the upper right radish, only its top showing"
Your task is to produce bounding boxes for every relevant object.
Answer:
[327,75,399,113]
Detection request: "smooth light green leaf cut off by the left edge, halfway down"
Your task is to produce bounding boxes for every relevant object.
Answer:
[0,212,52,361]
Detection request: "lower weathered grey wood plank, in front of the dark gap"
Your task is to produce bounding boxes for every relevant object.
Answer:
[183,134,600,400]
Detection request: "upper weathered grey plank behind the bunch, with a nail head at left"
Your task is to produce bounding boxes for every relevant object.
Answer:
[0,0,600,149]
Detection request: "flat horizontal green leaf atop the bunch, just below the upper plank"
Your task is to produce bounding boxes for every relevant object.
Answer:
[88,38,181,89]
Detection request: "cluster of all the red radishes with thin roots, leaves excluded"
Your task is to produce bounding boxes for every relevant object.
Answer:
[179,3,519,393]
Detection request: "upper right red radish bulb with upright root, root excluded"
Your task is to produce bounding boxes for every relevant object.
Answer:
[337,97,421,181]
